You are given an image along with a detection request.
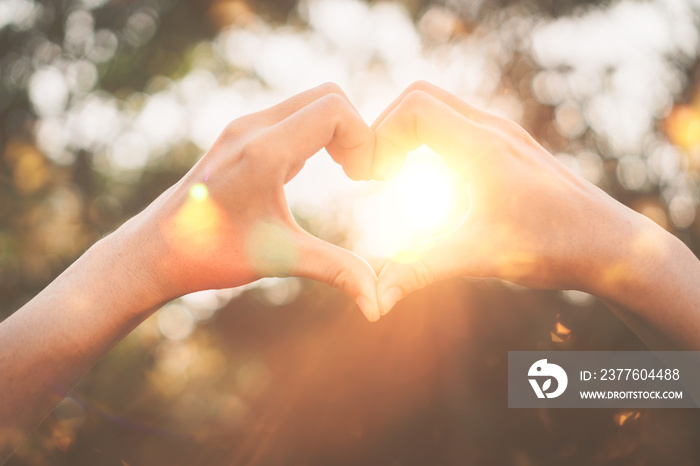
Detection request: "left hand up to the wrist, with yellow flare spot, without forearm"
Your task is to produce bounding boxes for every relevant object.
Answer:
[123,84,379,320]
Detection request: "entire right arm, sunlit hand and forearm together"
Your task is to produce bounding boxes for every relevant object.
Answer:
[372,82,700,350]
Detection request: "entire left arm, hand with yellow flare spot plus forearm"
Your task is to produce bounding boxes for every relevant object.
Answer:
[0,84,379,463]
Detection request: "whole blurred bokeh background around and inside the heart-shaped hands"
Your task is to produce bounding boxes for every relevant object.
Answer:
[0,0,700,466]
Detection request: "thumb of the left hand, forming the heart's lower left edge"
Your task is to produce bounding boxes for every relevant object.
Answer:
[293,229,380,322]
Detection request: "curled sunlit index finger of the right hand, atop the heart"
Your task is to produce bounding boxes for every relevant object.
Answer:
[372,91,492,180]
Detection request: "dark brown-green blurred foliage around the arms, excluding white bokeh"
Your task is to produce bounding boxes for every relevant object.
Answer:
[0,0,700,466]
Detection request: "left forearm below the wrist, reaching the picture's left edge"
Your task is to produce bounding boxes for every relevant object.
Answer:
[0,223,166,463]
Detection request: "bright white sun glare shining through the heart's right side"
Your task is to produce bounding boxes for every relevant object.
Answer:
[356,146,468,258]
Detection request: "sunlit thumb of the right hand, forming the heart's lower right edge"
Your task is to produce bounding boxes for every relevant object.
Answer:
[377,229,476,315]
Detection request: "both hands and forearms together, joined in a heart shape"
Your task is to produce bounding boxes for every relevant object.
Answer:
[0,82,700,462]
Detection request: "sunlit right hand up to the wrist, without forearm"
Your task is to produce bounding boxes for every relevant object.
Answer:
[372,82,646,314]
